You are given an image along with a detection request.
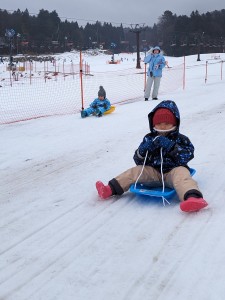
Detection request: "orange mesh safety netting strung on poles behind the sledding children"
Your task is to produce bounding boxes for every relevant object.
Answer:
[0,62,183,124]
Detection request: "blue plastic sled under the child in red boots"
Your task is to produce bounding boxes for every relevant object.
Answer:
[130,168,196,199]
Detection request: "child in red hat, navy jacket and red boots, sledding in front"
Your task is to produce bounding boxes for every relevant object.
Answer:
[96,100,208,212]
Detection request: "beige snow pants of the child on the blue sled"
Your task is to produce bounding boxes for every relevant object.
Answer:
[109,166,201,201]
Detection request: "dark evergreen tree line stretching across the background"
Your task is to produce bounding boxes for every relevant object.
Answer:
[0,9,225,56]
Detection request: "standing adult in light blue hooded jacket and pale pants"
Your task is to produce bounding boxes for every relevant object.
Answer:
[144,46,166,101]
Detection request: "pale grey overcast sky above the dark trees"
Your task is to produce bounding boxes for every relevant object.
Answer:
[0,0,225,26]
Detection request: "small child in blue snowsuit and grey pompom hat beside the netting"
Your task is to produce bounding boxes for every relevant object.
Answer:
[81,86,111,118]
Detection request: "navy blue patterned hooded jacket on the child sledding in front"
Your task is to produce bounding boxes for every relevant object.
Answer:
[134,100,194,173]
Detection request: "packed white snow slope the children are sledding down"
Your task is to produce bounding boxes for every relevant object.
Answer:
[0,54,225,300]
